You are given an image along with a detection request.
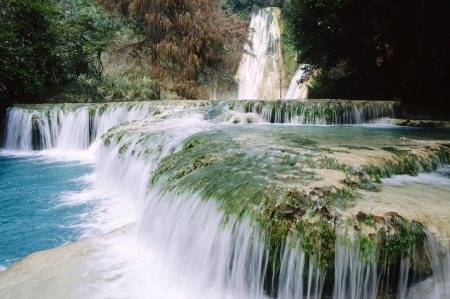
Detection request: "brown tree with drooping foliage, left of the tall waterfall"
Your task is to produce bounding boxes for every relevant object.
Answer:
[99,0,248,99]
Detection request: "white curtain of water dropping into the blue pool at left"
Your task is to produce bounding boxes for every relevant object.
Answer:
[4,103,150,150]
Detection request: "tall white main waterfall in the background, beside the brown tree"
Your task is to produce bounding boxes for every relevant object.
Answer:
[237,8,283,99]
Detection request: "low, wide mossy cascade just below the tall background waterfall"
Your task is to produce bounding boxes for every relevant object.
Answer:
[230,100,394,125]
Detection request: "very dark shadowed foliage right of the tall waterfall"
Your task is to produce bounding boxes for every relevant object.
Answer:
[284,0,450,106]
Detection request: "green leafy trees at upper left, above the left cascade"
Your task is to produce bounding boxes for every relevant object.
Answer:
[0,0,125,102]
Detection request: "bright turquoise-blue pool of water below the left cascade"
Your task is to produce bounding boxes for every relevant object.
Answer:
[0,150,94,271]
